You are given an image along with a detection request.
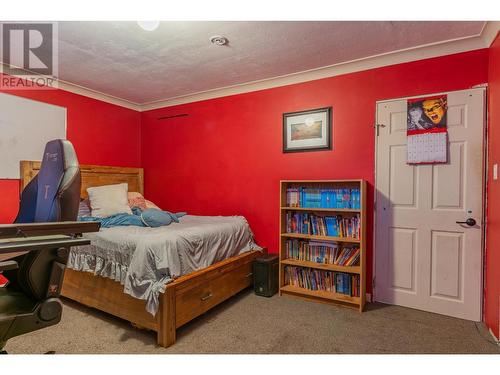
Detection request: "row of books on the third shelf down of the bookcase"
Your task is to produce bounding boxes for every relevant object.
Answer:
[285,239,361,267]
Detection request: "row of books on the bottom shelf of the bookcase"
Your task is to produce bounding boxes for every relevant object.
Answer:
[285,266,360,297]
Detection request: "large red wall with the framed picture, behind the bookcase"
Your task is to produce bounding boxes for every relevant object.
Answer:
[142,49,488,296]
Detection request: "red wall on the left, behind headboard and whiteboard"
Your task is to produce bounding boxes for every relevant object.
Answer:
[0,79,141,223]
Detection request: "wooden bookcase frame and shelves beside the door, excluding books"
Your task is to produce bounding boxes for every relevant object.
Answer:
[279,180,366,312]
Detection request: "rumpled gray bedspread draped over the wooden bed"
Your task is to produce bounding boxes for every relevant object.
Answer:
[68,215,260,315]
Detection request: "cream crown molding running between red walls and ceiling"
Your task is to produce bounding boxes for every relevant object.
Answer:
[0,21,500,112]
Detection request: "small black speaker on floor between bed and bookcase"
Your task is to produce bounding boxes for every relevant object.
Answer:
[253,255,279,297]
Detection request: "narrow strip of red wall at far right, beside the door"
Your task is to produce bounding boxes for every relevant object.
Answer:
[484,36,500,338]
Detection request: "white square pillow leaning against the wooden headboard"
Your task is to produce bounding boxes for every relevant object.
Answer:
[87,183,132,217]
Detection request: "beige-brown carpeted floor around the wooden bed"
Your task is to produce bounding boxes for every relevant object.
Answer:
[6,290,500,354]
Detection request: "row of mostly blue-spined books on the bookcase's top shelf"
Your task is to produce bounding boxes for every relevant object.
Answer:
[286,186,361,209]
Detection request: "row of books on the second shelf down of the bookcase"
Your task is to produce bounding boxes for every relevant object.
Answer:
[286,212,361,238]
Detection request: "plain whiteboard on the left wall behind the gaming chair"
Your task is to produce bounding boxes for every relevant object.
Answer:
[0,93,66,179]
